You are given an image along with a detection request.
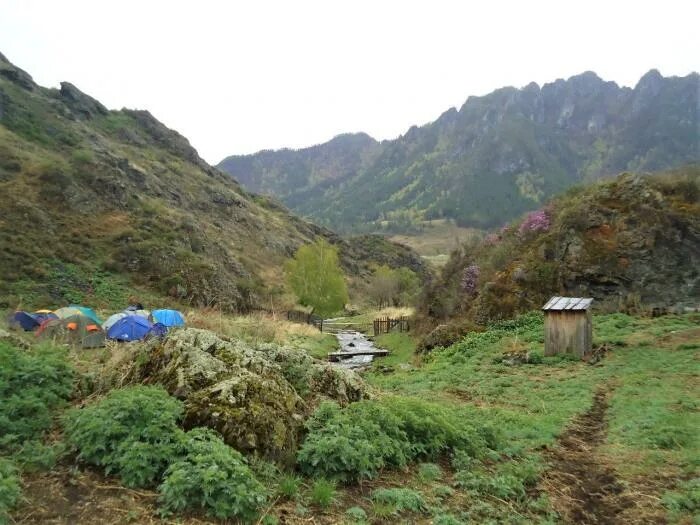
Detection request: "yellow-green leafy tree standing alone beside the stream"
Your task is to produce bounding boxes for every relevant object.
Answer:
[285,239,348,315]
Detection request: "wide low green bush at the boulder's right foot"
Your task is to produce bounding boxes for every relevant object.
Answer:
[297,397,496,481]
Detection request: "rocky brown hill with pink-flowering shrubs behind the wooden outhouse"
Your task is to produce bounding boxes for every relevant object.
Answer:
[422,166,700,323]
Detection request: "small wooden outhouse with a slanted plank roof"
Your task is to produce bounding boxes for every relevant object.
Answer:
[542,297,593,358]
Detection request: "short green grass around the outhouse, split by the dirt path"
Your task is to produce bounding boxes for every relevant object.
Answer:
[369,314,700,520]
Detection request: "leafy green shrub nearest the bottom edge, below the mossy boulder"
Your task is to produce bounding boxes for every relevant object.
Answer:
[159,428,266,521]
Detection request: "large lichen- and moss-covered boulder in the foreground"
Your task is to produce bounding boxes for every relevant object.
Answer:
[129,328,369,459]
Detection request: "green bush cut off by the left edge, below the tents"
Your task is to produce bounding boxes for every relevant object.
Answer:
[0,342,74,452]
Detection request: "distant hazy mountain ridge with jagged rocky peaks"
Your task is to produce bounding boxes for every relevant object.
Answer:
[219,70,700,231]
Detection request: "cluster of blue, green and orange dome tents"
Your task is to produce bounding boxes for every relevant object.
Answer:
[10,304,185,348]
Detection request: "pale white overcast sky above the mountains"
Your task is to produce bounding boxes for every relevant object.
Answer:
[0,0,700,163]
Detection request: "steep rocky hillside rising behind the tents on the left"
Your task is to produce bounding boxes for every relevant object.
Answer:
[0,51,422,309]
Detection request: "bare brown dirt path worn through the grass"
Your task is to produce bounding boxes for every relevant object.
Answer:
[542,389,631,524]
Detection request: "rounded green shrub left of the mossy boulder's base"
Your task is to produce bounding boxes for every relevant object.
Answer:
[65,380,183,487]
